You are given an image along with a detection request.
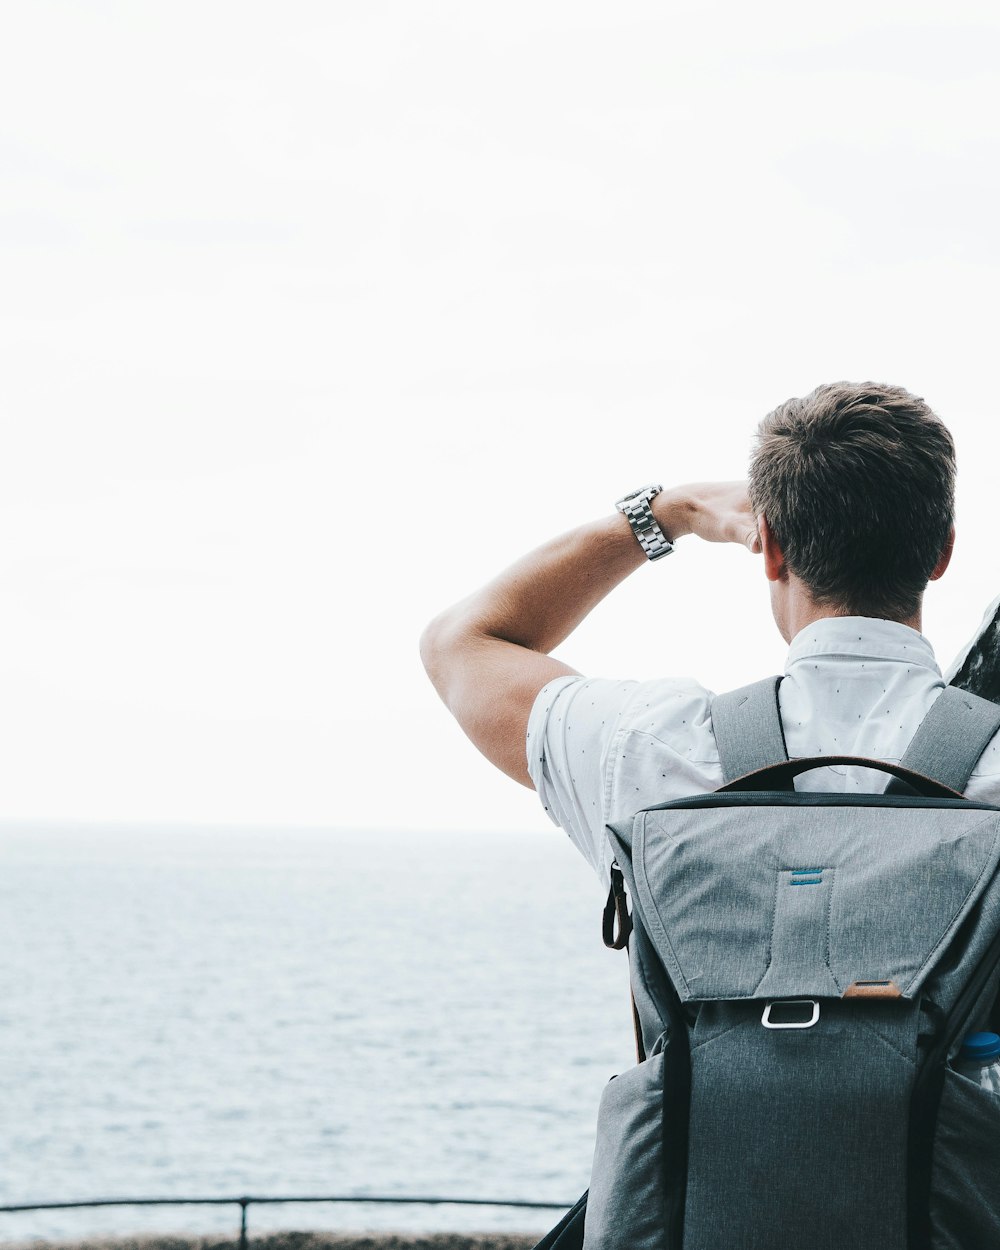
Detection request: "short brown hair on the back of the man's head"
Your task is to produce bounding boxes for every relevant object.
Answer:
[750,383,955,620]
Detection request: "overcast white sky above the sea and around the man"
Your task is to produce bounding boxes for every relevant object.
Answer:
[0,0,1000,829]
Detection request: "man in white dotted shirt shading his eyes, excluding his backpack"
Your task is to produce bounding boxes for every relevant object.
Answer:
[421,383,1000,880]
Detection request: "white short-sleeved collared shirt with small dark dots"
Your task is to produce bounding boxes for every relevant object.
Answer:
[528,616,1000,881]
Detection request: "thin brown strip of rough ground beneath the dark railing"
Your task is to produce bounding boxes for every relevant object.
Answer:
[3,1233,538,1250]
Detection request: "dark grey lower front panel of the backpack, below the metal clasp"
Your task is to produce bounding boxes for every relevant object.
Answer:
[684,1003,915,1250]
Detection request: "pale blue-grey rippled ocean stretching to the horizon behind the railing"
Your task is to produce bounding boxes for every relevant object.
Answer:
[0,826,634,1243]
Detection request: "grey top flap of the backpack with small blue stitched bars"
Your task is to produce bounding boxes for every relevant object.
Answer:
[631,796,1000,1008]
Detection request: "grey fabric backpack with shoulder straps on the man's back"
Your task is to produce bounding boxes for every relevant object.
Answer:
[582,679,1000,1250]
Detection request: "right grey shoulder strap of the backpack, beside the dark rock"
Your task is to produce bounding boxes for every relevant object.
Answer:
[900,686,1000,794]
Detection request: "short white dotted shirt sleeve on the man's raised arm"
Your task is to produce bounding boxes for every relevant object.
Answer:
[526,676,638,879]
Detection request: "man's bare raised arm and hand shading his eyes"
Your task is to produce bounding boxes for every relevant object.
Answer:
[420,483,760,786]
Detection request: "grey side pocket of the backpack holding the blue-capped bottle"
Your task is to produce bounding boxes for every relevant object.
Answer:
[930,1071,1000,1250]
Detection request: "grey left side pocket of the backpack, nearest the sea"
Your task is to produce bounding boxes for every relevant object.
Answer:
[584,1053,664,1250]
